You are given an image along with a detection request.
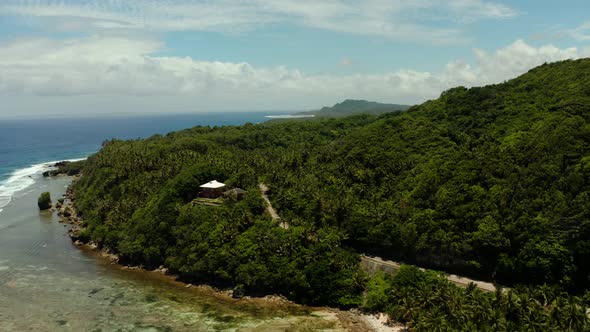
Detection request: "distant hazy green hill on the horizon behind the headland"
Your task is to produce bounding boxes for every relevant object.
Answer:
[295,99,411,117]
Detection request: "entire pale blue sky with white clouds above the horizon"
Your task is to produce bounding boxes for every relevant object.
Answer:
[0,0,590,118]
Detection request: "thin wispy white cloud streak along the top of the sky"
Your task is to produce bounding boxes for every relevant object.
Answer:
[0,0,517,43]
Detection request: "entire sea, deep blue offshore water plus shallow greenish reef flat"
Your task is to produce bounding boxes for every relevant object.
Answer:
[0,113,343,332]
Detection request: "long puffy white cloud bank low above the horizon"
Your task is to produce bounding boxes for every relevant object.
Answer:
[0,37,590,111]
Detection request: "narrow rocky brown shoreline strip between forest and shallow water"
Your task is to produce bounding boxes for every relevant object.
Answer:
[56,174,403,332]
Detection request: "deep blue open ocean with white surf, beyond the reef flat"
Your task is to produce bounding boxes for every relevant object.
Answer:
[0,112,285,213]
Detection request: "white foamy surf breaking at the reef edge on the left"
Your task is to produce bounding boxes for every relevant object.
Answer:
[0,158,86,212]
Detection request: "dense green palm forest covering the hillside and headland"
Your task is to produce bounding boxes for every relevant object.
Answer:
[75,59,590,331]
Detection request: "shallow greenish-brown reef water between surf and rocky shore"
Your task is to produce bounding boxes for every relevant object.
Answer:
[0,177,338,332]
